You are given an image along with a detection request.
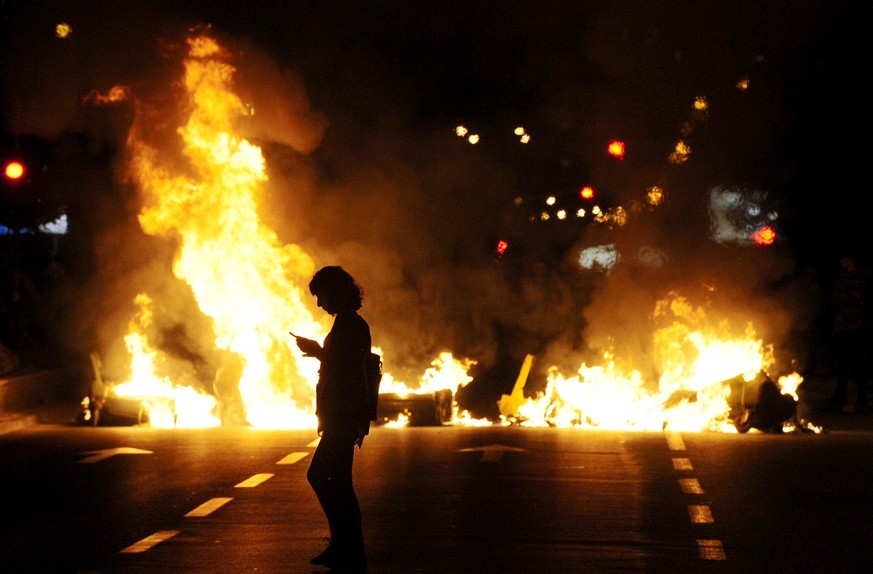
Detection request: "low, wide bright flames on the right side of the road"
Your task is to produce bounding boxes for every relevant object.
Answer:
[502,293,820,432]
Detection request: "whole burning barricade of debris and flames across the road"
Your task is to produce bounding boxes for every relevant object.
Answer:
[23,24,820,432]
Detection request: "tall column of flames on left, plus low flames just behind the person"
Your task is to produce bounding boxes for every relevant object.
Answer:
[105,30,480,428]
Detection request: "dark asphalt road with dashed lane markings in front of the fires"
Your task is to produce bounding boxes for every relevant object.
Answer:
[0,425,873,574]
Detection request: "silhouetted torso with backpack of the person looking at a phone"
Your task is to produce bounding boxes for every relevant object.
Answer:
[315,311,372,428]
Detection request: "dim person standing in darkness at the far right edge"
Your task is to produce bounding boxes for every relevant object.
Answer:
[831,253,871,412]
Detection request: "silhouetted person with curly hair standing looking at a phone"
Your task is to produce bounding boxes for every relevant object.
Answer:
[292,266,372,571]
